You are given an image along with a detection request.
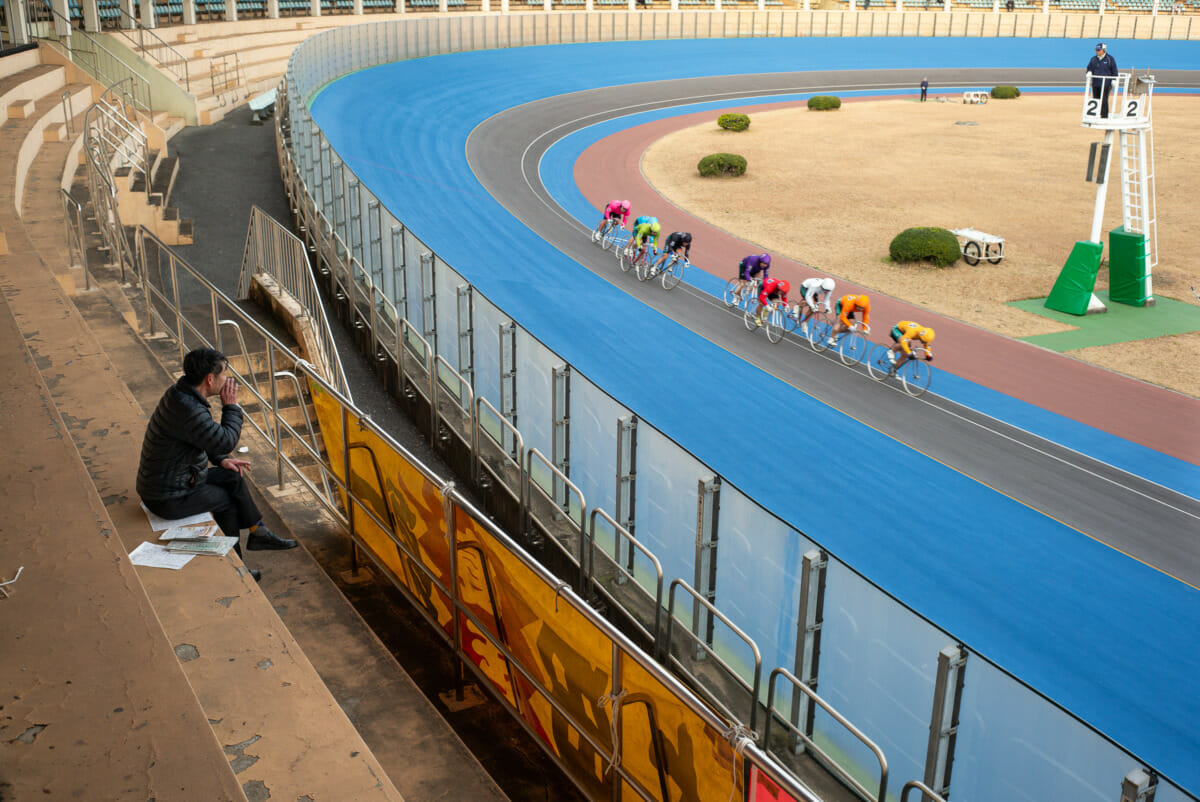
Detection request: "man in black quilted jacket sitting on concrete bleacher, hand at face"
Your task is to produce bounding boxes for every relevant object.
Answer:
[137,348,296,580]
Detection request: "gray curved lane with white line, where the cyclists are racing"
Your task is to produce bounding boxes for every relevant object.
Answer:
[467,70,1200,587]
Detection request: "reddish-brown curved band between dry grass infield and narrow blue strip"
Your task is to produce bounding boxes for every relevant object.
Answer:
[575,102,1200,465]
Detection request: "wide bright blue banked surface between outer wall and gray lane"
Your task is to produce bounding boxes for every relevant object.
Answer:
[313,38,1200,792]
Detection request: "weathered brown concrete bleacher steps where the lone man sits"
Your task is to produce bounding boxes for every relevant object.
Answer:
[0,43,503,800]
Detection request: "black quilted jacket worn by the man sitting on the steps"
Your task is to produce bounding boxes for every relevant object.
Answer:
[138,378,242,501]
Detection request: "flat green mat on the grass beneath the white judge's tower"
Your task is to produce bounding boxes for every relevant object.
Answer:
[1009,292,1200,351]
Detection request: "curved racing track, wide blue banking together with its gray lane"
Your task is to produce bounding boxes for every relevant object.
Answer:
[313,40,1200,791]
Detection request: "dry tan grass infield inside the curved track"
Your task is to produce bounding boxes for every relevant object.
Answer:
[642,95,1200,396]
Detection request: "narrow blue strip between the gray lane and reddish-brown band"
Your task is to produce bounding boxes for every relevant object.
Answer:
[539,86,1200,498]
